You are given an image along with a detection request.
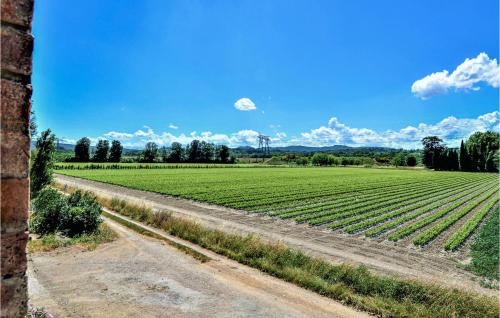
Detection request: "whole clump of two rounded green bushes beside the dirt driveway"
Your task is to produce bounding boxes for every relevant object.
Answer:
[30,188,101,237]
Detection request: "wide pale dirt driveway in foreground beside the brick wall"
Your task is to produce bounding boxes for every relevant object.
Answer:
[28,214,368,318]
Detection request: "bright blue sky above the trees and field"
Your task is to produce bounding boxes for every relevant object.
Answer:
[33,0,500,147]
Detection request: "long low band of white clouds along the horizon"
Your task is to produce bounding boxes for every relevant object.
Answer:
[84,111,500,149]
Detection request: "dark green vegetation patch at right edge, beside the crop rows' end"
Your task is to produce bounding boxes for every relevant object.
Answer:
[466,207,500,287]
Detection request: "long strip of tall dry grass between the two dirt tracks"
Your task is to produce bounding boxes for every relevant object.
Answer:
[52,181,500,317]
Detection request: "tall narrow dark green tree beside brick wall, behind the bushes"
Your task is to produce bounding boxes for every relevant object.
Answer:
[30,129,56,196]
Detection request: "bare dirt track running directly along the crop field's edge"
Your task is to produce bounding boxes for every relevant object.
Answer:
[56,175,496,296]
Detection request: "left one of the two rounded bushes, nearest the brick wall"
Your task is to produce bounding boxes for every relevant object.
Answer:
[30,188,69,235]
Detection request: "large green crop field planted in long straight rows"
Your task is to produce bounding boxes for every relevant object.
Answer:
[57,167,499,251]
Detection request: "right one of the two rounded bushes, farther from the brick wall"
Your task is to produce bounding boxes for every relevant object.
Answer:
[59,191,102,237]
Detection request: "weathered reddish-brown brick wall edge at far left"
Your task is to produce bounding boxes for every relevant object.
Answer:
[0,0,33,318]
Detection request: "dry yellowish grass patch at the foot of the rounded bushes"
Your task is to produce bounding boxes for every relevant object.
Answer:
[28,224,117,253]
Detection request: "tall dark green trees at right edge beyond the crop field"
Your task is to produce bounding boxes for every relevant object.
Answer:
[422,131,500,172]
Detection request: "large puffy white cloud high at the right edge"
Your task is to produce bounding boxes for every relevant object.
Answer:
[411,52,500,99]
